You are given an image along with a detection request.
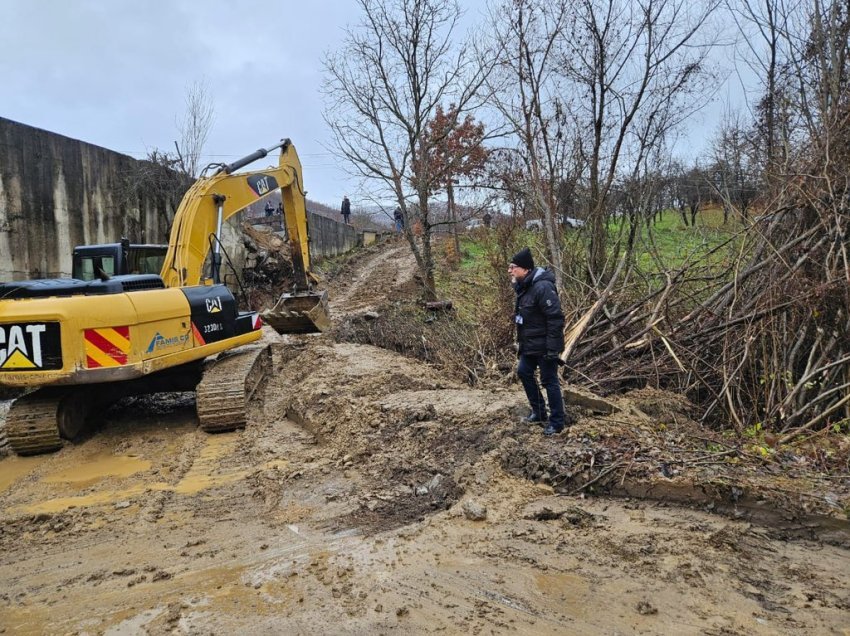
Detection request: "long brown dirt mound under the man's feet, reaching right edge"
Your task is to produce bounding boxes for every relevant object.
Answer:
[272,343,850,544]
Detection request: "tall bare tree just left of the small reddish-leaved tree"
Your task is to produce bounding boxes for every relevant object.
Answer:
[324,0,489,298]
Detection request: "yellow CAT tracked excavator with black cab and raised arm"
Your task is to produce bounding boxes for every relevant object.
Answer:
[0,139,330,455]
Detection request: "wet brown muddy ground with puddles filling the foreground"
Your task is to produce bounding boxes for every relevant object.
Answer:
[0,245,850,636]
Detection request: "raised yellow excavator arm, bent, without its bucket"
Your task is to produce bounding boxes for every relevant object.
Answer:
[161,139,313,290]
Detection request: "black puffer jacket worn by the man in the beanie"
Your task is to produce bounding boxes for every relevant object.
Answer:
[514,267,564,356]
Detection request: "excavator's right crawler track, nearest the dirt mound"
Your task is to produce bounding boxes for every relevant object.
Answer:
[196,346,272,433]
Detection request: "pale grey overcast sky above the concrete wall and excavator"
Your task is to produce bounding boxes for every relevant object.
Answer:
[0,0,735,205]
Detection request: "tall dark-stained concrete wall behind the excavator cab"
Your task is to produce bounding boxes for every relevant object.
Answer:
[0,117,179,280]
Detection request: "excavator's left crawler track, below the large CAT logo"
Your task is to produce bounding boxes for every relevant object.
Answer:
[6,390,73,455]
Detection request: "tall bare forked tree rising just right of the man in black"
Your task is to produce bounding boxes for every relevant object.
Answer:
[564,0,717,279]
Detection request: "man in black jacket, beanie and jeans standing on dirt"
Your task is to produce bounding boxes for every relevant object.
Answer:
[508,247,565,435]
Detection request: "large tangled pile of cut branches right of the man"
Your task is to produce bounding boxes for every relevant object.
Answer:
[566,138,850,443]
